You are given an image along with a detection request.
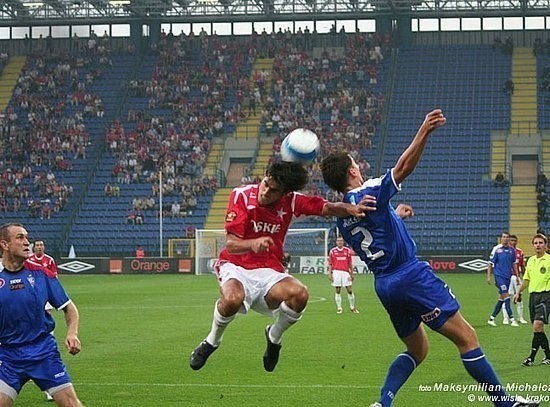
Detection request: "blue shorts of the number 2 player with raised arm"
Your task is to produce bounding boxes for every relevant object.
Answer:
[374,260,460,338]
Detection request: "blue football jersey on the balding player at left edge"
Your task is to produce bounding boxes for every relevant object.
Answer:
[0,268,70,345]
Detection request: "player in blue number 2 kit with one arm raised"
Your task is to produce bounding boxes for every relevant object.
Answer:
[321,109,538,407]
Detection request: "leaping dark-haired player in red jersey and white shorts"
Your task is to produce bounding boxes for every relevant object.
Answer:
[189,162,375,372]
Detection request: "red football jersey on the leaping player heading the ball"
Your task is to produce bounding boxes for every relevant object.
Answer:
[219,184,327,272]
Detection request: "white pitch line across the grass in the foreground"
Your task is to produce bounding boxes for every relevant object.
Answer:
[74,382,380,389]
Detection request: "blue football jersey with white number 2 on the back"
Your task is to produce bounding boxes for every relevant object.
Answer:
[337,169,416,274]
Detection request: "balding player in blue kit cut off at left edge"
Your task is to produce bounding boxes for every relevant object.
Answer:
[0,223,82,407]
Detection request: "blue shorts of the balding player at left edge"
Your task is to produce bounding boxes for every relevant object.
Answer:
[0,335,71,399]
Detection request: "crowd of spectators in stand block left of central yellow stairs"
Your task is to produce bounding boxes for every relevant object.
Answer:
[110,31,280,225]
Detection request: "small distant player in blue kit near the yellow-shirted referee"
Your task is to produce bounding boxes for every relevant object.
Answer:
[487,232,519,326]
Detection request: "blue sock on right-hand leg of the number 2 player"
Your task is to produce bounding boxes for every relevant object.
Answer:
[460,348,513,407]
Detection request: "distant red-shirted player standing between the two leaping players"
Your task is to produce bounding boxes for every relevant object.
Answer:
[328,237,359,314]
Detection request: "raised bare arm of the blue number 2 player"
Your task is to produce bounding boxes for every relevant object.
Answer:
[393,109,447,184]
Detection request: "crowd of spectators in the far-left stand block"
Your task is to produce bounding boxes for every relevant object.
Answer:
[0,41,108,218]
